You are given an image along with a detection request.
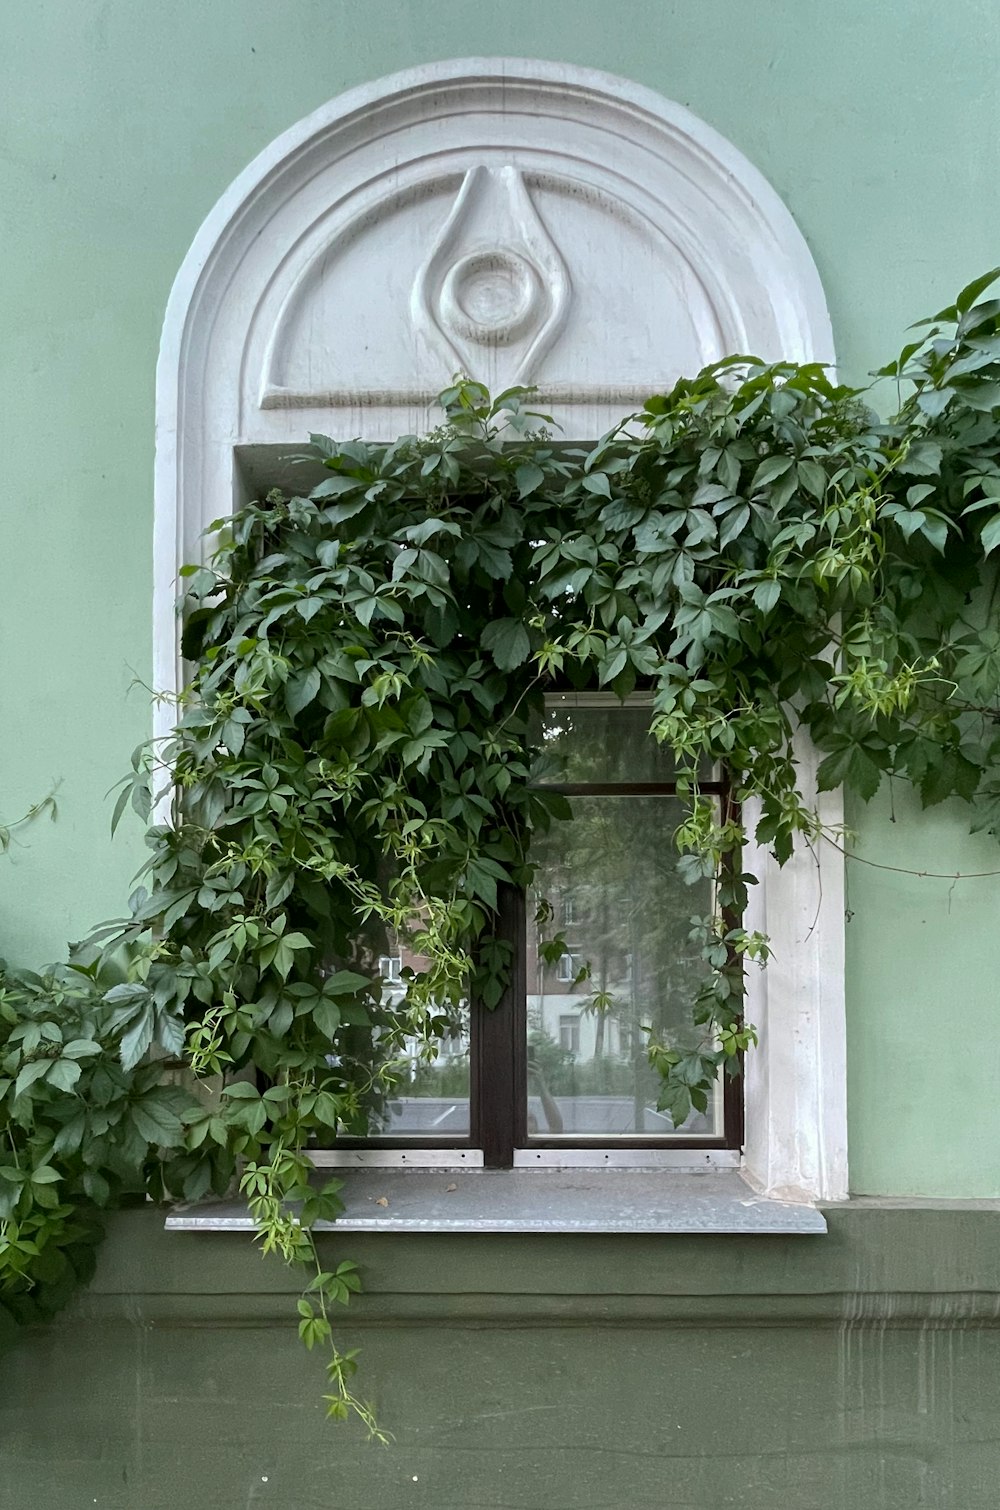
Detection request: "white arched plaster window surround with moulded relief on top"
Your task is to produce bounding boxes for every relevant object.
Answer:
[154,59,847,1200]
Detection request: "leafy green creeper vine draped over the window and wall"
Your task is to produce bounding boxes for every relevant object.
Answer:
[0,278,1000,1424]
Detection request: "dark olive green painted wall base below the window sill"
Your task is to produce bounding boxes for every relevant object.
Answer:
[0,1202,1000,1510]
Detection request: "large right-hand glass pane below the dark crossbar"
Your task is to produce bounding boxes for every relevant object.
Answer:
[527,796,722,1139]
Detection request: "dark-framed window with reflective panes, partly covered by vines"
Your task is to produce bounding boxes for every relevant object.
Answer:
[324,693,742,1167]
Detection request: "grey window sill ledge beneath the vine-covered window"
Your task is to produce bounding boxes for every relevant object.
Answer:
[166,1169,826,1237]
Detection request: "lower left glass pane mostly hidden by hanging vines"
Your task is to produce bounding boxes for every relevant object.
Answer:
[336,938,470,1142]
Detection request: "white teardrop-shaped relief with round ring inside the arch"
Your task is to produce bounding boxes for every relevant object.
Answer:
[411,165,573,391]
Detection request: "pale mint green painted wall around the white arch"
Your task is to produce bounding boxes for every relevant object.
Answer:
[0,0,1000,1196]
